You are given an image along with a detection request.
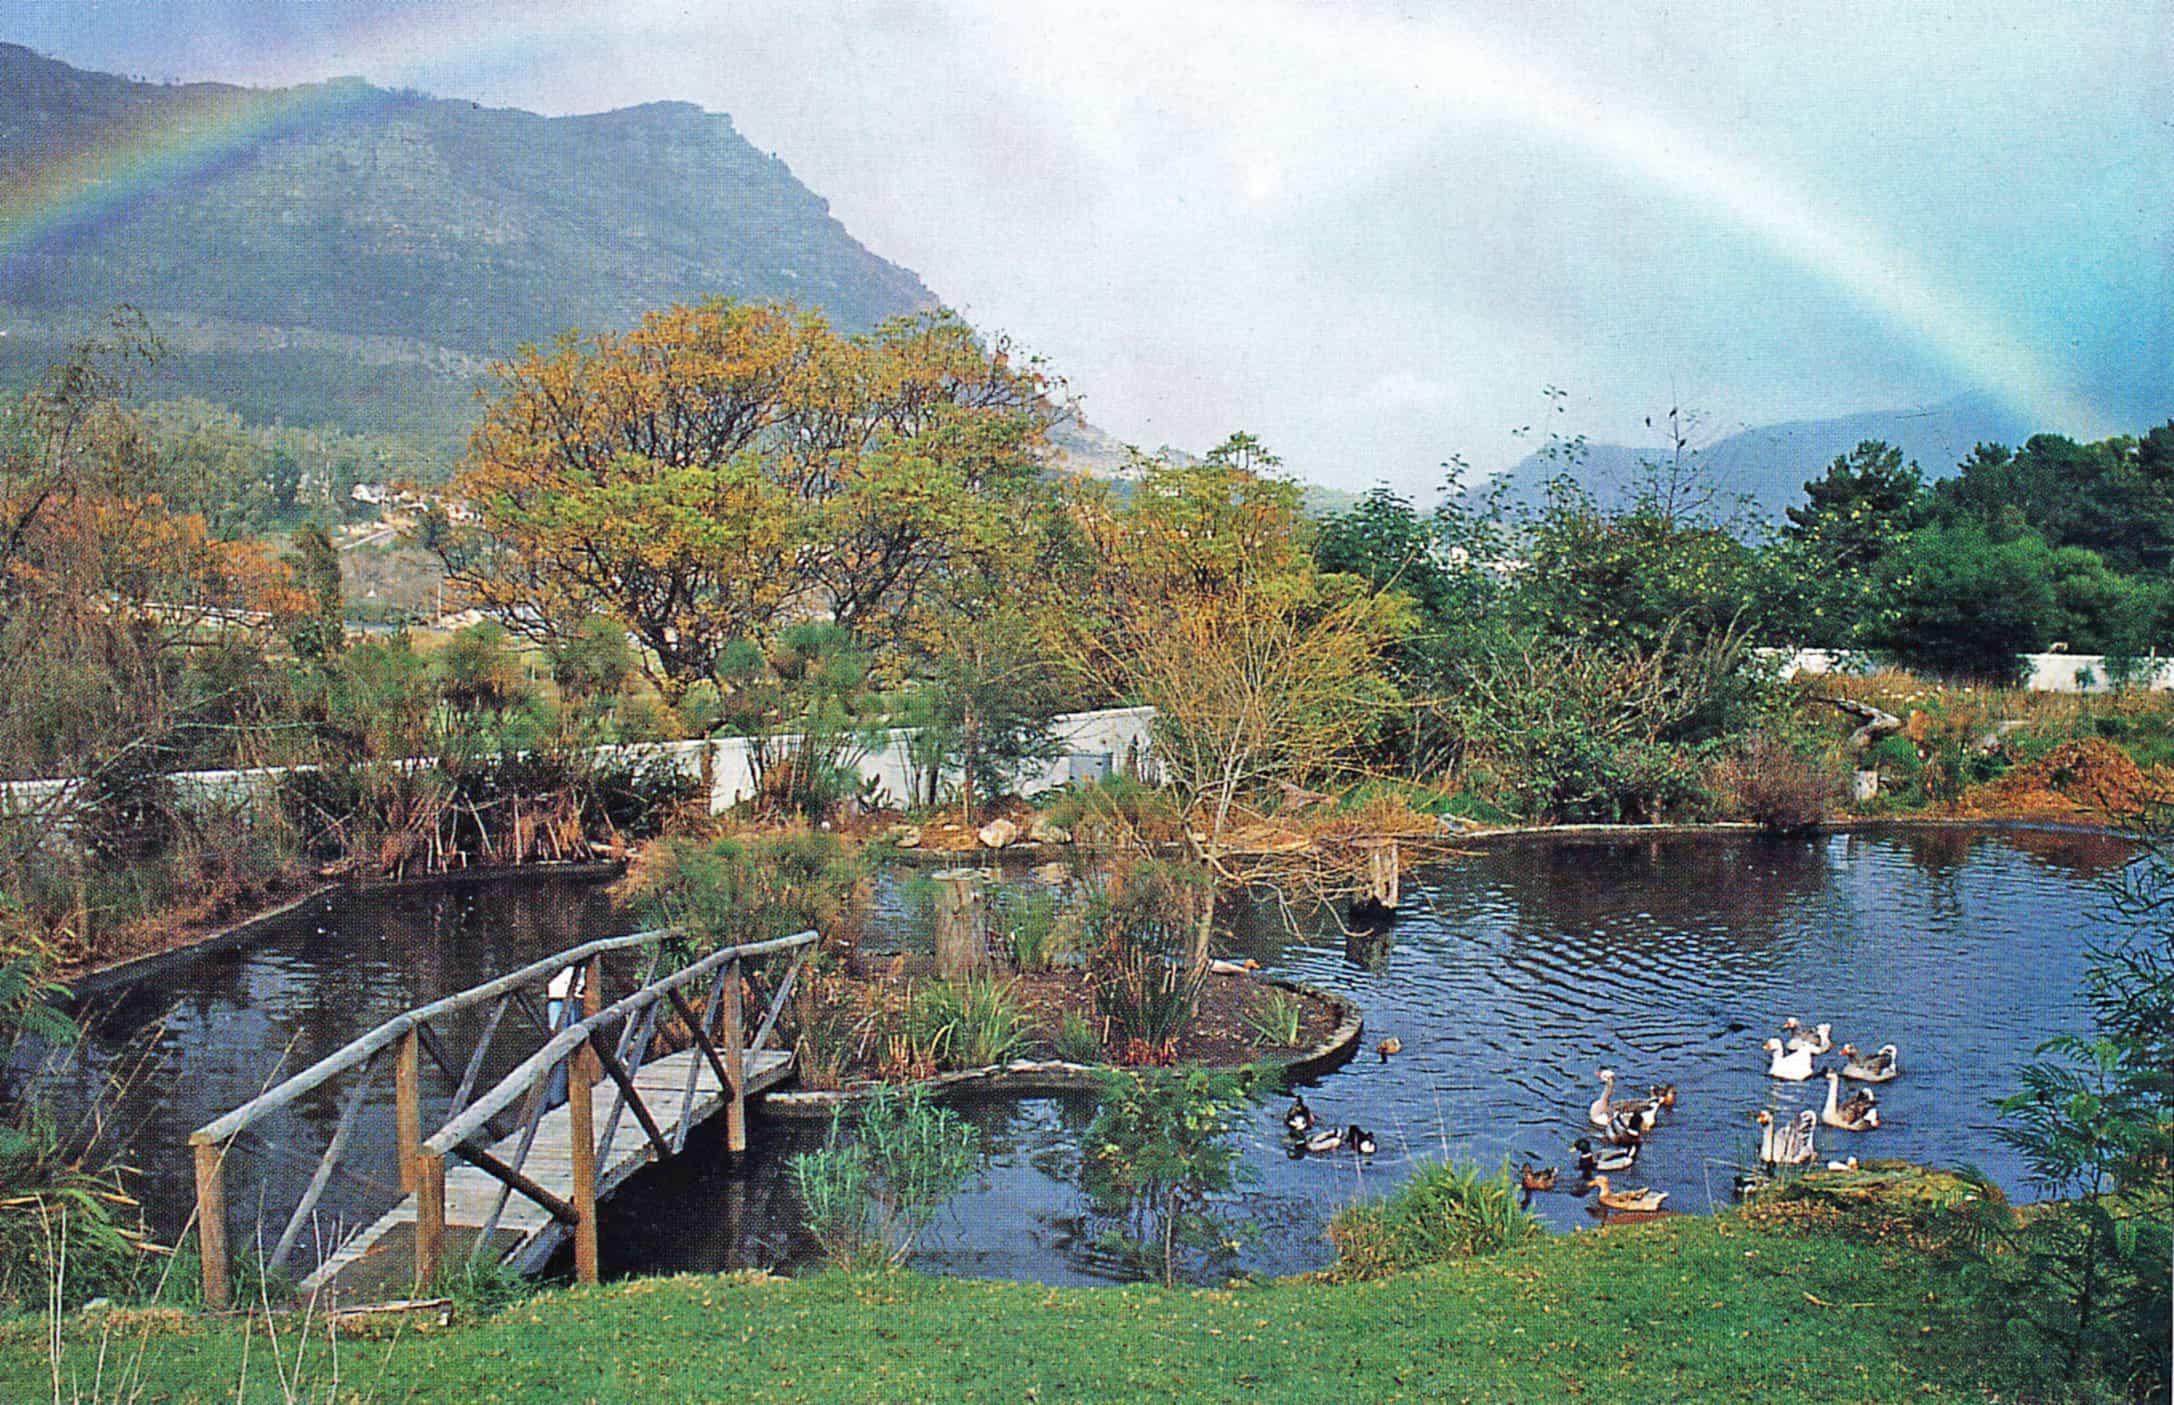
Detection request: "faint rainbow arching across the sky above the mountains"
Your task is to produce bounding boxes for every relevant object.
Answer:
[0,0,2113,435]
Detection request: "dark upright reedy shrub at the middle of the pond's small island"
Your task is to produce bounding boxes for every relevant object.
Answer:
[1085,863,1209,1064]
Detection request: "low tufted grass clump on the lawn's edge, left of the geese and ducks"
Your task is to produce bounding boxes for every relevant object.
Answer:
[1328,1161,1541,1283]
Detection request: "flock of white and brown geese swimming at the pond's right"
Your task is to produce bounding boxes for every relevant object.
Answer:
[1517,1018,1900,1214]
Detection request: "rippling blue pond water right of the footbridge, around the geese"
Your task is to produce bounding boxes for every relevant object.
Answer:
[604,829,2131,1283]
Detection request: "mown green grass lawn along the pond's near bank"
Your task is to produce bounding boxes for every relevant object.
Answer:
[0,1216,2015,1405]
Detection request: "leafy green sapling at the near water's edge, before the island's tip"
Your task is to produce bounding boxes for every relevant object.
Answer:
[1080,1068,1252,1285]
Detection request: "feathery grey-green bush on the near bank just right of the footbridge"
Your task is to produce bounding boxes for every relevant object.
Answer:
[787,1087,980,1268]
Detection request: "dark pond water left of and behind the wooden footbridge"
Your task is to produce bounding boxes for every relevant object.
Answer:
[9,879,620,1278]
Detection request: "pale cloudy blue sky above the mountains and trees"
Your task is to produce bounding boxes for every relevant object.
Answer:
[0,0,2174,494]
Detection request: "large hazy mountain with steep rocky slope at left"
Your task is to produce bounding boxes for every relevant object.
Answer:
[0,43,937,446]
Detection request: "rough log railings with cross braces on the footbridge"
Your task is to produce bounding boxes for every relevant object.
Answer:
[189,929,817,1309]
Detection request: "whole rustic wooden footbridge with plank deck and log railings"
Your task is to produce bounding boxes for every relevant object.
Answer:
[189,931,815,1309]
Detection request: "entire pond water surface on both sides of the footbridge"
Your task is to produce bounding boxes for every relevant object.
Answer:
[12,829,2128,1283]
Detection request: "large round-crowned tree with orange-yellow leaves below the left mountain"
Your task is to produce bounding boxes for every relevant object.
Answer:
[441,298,1059,700]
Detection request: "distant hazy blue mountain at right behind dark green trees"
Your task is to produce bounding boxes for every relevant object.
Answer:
[1472,396,2037,518]
